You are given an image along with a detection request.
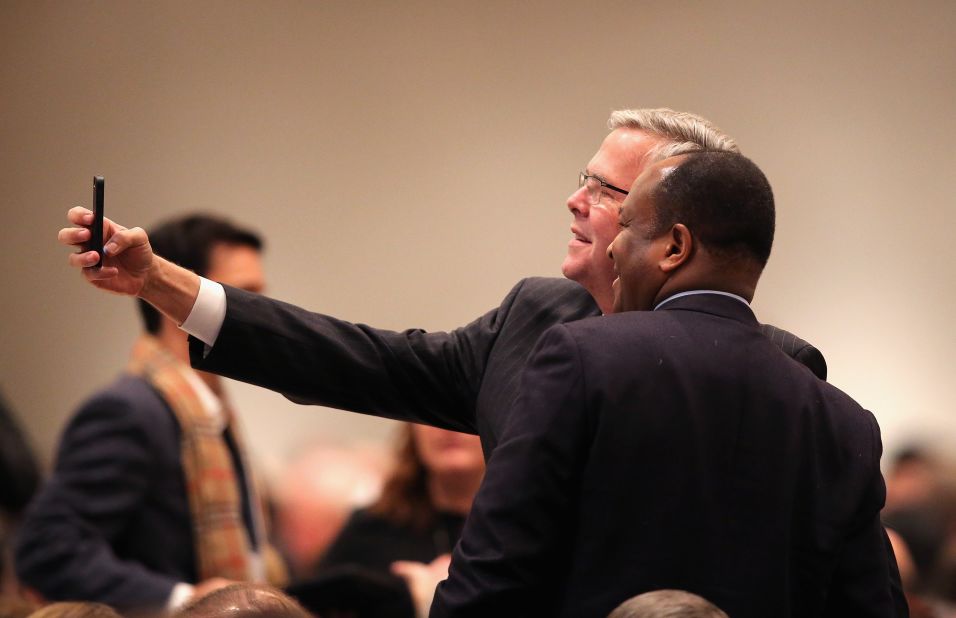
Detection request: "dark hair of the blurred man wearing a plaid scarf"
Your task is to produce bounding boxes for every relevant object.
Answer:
[139,215,262,335]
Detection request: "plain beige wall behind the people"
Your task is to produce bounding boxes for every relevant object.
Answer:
[0,0,956,476]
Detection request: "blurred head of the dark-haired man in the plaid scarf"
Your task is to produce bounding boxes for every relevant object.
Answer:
[139,215,265,335]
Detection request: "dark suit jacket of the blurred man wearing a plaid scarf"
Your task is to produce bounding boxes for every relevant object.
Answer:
[16,375,249,609]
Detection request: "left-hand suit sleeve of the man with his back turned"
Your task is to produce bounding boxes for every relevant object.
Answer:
[431,326,593,617]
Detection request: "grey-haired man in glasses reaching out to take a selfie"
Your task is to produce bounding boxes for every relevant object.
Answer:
[59,109,826,458]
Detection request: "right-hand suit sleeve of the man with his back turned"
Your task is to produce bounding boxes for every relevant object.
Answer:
[825,415,909,618]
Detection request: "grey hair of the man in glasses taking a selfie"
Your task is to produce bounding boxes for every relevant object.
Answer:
[607,107,740,161]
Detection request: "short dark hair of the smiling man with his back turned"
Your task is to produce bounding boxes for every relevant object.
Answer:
[651,151,776,267]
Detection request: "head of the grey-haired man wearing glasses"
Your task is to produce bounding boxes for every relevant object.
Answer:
[561,108,739,313]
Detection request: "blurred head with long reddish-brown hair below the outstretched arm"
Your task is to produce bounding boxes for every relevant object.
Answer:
[369,423,485,529]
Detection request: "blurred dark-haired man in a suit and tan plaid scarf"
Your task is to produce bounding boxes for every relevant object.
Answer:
[16,216,283,610]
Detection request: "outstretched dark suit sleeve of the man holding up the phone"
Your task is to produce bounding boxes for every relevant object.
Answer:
[190,282,523,433]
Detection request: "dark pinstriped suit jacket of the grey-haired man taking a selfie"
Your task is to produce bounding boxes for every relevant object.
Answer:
[190,278,826,459]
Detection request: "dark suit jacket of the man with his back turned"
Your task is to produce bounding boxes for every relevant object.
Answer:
[432,294,905,618]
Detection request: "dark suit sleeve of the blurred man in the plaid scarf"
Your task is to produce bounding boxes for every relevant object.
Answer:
[16,395,177,607]
